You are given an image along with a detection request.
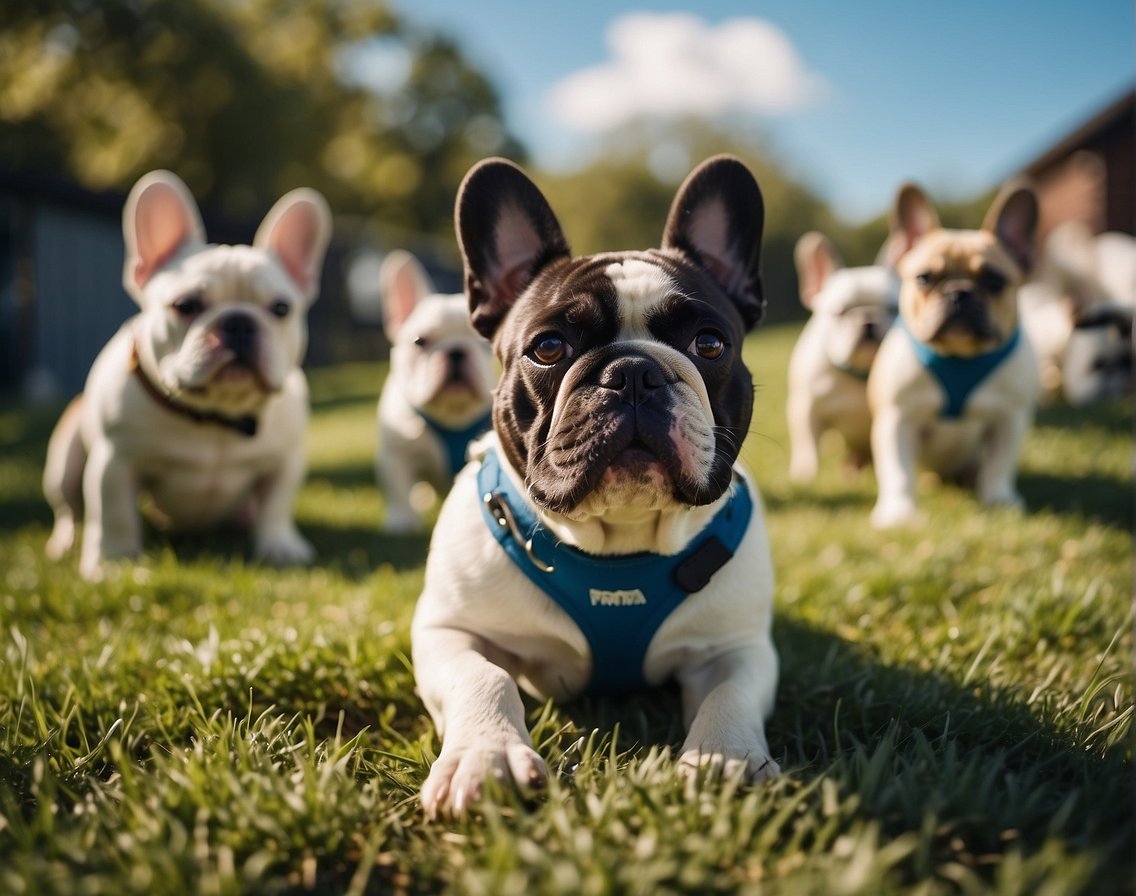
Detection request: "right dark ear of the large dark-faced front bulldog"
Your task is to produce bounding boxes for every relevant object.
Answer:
[662,156,766,329]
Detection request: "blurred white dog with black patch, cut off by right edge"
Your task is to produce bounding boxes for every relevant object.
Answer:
[1020,220,1136,407]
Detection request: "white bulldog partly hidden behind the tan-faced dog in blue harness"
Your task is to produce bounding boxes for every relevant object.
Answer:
[786,231,900,482]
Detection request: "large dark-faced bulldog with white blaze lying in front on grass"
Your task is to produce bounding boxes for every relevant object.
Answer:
[411,157,777,817]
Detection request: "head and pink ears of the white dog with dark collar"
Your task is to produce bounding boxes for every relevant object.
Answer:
[124,171,331,416]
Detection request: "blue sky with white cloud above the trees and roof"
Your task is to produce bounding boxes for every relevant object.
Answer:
[395,0,1136,221]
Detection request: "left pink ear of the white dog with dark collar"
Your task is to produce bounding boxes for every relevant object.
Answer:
[123,170,206,304]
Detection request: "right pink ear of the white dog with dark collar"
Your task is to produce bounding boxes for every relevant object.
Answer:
[252,187,332,300]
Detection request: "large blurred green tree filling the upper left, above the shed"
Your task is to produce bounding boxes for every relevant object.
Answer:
[0,0,524,238]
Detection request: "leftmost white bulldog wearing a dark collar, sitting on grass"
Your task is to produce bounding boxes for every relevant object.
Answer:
[43,171,332,579]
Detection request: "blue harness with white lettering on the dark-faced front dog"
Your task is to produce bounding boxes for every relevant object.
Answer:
[477,449,753,694]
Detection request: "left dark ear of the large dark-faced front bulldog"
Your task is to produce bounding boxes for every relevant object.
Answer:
[454,159,570,338]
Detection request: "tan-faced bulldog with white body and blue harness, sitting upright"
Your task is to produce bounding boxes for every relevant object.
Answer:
[868,183,1039,527]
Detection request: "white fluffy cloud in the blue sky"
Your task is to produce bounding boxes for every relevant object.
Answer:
[548,12,825,133]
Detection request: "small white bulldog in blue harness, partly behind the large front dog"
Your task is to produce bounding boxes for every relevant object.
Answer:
[375,250,496,533]
